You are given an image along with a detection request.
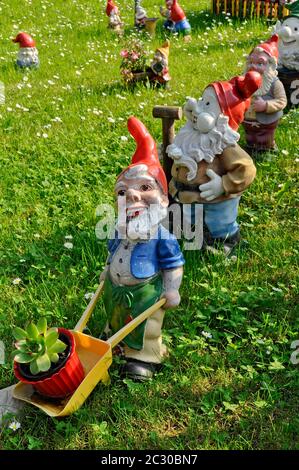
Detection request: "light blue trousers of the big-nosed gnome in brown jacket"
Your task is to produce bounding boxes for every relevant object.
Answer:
[185,196,240,239]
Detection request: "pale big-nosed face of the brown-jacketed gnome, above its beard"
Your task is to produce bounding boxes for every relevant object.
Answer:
[184,87,221,133]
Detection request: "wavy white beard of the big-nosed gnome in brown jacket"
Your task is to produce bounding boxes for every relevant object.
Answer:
[167,114,240,181]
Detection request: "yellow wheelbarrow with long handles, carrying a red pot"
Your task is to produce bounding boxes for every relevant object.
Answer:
[13,282,165,417]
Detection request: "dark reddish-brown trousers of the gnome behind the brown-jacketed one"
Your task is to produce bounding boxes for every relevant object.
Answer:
[243,120,279,152]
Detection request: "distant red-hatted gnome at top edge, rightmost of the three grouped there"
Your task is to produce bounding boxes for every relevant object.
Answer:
[160,0,191,42]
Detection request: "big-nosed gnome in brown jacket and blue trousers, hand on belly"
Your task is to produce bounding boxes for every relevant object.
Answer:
[166,72,261,254]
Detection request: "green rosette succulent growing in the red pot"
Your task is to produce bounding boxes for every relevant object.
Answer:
[13,318,67,375]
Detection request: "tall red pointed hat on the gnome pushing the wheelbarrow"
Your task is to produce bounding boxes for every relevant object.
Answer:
[117,116,168,194]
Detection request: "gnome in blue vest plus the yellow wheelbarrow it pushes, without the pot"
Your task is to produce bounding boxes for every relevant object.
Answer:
[9,117,184,417]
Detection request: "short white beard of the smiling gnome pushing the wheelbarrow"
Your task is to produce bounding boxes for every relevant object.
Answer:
[117,204,167,240]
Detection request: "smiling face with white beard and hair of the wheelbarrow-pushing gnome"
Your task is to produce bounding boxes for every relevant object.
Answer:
[115,164,168,240]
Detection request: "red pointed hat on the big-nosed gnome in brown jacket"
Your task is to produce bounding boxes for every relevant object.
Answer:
[209,71,262,131]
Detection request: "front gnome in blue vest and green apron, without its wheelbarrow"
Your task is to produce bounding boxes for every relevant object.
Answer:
[100,117,184,380]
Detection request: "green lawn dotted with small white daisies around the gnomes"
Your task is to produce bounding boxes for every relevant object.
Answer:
[0,0,299,449]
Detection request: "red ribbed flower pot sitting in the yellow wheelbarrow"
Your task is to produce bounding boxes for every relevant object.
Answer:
[14,328,84,398]
